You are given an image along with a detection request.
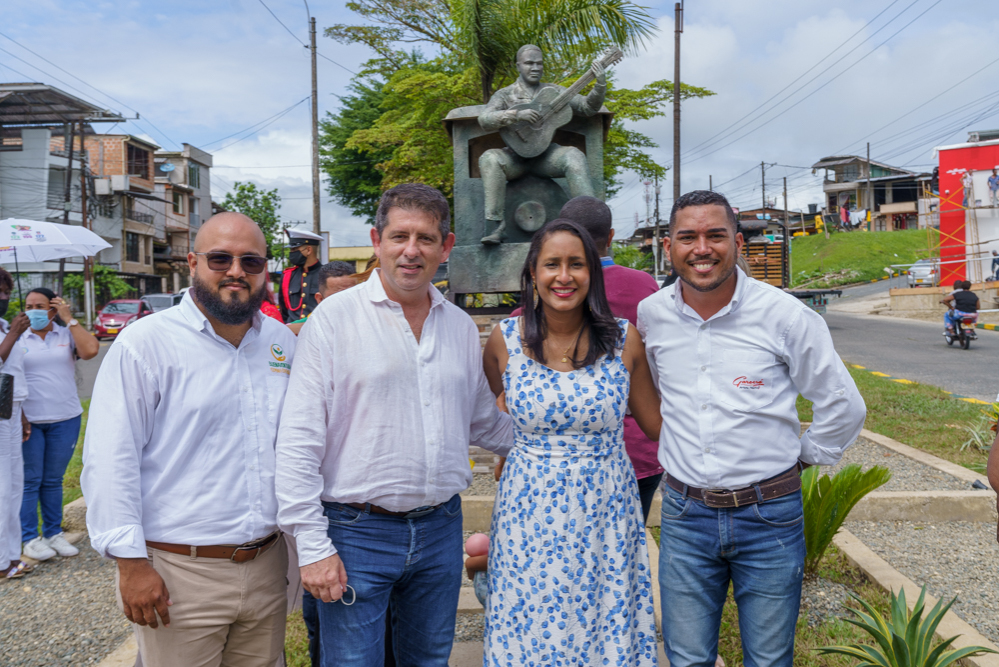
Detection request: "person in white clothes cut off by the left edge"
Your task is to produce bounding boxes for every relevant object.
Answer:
[0,269,31,579]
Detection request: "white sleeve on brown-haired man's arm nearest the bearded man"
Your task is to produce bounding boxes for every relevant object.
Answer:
[274,321,337,567]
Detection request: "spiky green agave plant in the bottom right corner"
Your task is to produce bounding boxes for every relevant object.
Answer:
[816,586,996,667]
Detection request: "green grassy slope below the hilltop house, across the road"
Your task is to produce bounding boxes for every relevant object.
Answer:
[791,229,940,288]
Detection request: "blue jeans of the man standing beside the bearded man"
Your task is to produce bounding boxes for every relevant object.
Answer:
[319,495,464,667]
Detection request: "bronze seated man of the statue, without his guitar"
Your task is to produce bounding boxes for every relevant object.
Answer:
[479,44,607,245]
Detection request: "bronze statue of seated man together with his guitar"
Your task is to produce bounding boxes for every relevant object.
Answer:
[479,44,622,245]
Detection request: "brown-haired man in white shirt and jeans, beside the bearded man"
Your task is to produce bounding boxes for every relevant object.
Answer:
[277,184,513,667]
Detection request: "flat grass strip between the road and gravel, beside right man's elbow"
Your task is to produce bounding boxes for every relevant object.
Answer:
[798,364,988,473]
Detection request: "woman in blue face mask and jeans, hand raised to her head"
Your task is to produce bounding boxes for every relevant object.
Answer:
[20,287,101,560]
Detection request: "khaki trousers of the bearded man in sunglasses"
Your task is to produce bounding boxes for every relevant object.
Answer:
[115,535,288,667]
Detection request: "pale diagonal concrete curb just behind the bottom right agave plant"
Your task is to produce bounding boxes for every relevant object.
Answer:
[833,530,999,667]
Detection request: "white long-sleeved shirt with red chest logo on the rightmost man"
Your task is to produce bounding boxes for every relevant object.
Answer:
[638,269,867,490]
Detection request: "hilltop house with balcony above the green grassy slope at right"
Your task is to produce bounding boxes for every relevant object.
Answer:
[812,155,930,231]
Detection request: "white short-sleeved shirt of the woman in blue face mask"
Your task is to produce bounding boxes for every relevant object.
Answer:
[18,322,83,424]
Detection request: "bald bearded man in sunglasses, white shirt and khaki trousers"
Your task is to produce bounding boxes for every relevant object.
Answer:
[81,213,295,667]
